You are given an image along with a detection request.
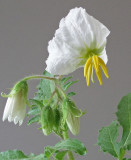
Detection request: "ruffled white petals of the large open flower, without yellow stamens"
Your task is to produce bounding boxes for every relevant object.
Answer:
[46,8,110,75]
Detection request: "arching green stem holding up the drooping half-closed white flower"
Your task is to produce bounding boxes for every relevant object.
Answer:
[23,75,56,81]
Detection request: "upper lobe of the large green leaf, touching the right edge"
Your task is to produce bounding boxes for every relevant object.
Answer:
[116,93,131,148]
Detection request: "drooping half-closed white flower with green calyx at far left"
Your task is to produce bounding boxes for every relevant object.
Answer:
[3,81,28,125]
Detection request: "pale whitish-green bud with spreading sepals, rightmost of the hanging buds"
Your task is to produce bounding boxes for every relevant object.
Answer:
[62,98,81,135]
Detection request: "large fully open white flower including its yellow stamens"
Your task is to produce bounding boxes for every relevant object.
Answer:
[46,8,110,85]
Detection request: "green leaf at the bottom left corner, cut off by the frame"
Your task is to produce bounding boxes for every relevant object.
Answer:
[0,150,46,160]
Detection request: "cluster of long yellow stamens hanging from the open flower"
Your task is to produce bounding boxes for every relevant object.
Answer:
[84,55,109,86]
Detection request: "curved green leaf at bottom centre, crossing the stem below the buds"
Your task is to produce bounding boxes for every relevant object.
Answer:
[45,139,87,158]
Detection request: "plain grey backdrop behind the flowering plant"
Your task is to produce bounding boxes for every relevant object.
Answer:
[0,0,131,160]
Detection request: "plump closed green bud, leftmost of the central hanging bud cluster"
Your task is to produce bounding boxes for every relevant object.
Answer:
[41,106,54,136]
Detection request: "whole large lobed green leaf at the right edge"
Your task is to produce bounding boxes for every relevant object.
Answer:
[98,93,131,160]
